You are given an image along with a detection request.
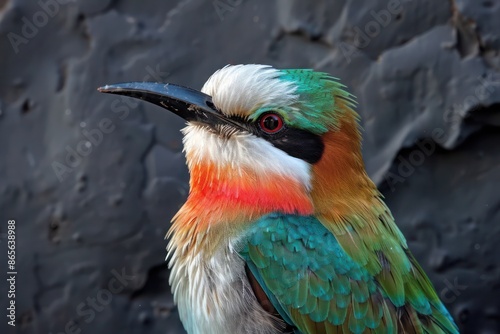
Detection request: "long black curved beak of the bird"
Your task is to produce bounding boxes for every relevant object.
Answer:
[97,82,241,128]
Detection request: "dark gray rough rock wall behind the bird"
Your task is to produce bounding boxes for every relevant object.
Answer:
[0,0,500,334]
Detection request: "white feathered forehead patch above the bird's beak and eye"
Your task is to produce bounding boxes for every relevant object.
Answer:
[201,64,297,116]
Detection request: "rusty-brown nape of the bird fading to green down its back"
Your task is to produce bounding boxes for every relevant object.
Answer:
[311,105,408,274]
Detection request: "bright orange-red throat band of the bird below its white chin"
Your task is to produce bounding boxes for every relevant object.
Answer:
[170,163,314,254]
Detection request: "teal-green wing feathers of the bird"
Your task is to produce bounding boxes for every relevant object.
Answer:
[240,214,458,334]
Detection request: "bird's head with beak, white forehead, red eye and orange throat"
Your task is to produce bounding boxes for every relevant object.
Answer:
[100,65,376,237]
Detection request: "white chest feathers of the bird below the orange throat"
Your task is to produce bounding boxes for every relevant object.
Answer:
[169,241,281,334]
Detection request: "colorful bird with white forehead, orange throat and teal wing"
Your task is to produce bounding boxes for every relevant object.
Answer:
[98,64,458,334]
